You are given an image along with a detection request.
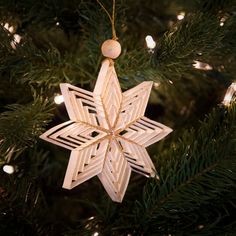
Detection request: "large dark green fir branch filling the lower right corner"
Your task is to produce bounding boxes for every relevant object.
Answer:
[131,105,236,233]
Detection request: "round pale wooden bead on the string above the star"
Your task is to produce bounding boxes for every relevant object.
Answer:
[102,39,121,59]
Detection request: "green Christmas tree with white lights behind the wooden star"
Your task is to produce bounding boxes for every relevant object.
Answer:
[0,0,236,236]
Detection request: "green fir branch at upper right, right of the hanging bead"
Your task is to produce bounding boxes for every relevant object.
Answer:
[155,12,224,81]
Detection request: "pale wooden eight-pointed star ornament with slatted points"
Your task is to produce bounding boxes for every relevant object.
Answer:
[41,39,172,202]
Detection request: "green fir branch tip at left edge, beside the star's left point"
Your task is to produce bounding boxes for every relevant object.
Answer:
[0,98,52,157]
